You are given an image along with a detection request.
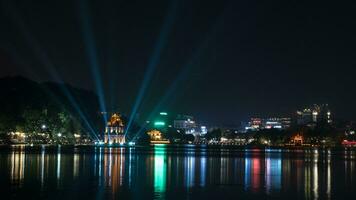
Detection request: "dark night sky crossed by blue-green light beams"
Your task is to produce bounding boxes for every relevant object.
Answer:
[0,0,356,125]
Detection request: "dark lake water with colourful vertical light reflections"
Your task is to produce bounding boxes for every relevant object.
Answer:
[0,146,356,199]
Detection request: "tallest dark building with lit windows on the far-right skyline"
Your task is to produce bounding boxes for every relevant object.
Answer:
[297,104,332,126]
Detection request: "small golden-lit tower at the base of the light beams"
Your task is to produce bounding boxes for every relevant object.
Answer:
[104,114,125,144]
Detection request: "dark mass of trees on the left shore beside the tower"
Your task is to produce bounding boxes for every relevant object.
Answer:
[0,77,104,143]
